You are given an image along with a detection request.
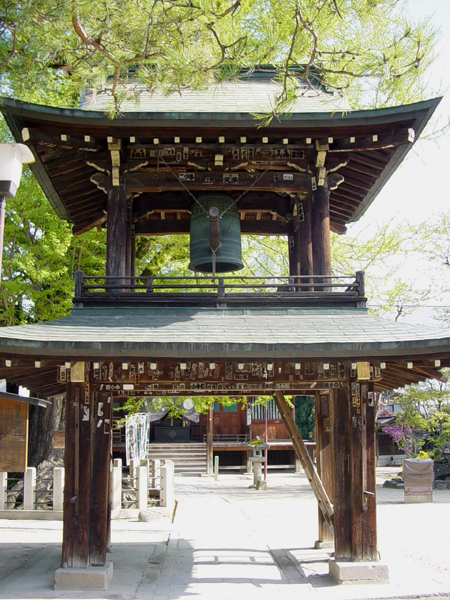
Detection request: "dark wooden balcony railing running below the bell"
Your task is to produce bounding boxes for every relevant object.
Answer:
[74,271,366,308]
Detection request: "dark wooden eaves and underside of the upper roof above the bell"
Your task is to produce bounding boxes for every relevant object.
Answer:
[2,99,439,235]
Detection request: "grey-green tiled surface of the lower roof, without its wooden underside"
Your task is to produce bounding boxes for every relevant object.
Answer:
[0,307,450,358]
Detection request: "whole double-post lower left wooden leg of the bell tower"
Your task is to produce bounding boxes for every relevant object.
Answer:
[61,362,112,568]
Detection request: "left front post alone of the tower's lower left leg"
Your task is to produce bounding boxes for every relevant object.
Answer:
[61,363,92,567]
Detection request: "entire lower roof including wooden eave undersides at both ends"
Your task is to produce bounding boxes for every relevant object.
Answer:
[0,307,450,396]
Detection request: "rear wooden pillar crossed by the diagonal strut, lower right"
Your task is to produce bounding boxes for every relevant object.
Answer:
[315,393,334,547]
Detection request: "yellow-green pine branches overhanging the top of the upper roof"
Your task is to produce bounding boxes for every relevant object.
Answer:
[0,0,436,116]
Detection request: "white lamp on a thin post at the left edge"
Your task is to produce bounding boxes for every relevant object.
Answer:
[0,144,34,278]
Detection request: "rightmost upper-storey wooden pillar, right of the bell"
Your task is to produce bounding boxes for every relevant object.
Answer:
[311,178,331,282]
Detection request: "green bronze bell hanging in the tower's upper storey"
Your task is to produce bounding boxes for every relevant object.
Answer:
[189,194,244,274]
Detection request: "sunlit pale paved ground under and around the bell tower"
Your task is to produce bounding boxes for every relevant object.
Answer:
[0,469,450,600]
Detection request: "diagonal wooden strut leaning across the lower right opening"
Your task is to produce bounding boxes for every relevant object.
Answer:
[274,392,334,527]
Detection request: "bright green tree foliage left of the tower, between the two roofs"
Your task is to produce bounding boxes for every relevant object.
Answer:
[0,115,106,325]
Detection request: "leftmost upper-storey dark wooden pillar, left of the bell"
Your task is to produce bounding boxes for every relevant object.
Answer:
[106,178,127,283]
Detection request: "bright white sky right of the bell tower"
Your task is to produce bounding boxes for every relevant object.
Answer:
[349,0,450,326]
